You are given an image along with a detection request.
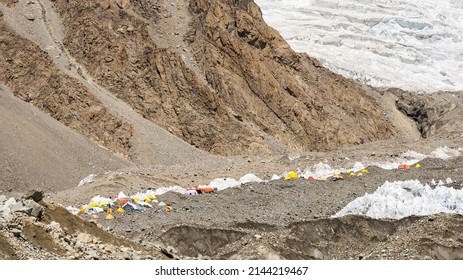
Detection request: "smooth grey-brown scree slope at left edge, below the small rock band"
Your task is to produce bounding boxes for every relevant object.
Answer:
[0,87,133,195]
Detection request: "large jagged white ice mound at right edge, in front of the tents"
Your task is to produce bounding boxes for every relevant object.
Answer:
[333,180,463,219]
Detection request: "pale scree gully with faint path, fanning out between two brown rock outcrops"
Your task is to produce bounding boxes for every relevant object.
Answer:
[0,0,218,165]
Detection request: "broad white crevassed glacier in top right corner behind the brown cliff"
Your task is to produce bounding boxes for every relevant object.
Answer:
[255,0,463,92]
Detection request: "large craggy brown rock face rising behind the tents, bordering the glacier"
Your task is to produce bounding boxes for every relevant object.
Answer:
[48,0,393,155]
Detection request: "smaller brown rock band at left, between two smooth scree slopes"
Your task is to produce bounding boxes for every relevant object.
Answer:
[0,19,132,155]
